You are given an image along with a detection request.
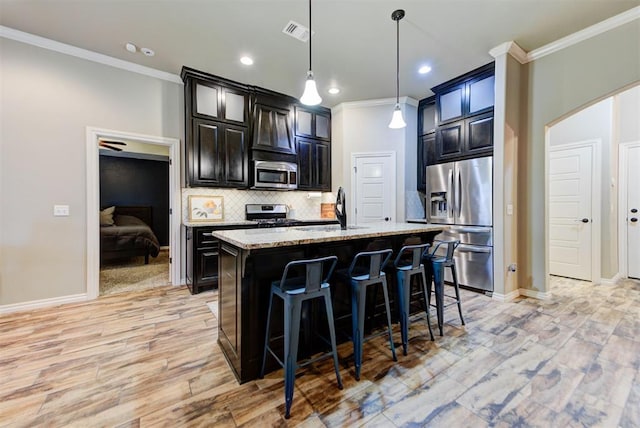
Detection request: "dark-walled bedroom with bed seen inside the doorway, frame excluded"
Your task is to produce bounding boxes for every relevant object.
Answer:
[98,143,170,296]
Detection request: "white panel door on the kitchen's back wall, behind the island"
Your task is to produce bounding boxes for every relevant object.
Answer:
[353,154,396,224]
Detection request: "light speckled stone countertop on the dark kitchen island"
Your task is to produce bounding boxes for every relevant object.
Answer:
[213,223,449,250]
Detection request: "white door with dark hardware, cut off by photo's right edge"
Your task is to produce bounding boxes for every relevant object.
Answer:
[626,146,640,279]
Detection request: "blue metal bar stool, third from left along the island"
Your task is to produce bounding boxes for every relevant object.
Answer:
[394,244,433,355]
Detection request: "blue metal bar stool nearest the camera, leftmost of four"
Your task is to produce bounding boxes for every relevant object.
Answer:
[260,256,342,419]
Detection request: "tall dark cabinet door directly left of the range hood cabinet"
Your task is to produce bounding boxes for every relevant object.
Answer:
[221,125,249,187]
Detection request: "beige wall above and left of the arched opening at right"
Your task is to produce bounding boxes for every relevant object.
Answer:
[518,20,640,291]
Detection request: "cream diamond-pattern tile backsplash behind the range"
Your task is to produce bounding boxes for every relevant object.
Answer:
[182,188,335,222]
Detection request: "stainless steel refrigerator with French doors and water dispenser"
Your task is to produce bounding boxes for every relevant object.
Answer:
[426,157,493,292]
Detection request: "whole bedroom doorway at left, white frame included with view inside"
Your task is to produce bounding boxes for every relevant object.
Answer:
[87,128,181,298]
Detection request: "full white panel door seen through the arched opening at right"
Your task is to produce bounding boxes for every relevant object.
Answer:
[549,146,593,281]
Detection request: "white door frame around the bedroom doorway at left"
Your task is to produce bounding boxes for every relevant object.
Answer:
[86,127,182,299]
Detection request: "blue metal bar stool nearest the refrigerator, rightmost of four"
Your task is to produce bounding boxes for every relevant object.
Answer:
[423,240,464,336]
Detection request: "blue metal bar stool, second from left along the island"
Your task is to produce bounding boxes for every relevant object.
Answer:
[341,249,398,380]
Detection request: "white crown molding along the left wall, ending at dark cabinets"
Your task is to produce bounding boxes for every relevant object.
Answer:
[0,25,182,85]
